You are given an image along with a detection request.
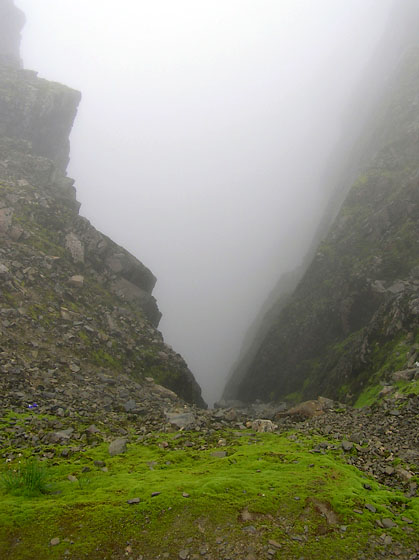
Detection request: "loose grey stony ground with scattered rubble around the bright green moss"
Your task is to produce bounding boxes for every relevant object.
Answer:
[0,364,419,560]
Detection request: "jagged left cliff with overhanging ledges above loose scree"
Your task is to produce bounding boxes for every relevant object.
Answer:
[0,0,205,406]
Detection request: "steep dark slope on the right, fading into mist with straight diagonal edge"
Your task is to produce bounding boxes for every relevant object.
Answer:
[224,4,419,401]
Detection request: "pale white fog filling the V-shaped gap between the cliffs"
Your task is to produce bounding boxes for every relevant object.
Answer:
[16,0,393,403]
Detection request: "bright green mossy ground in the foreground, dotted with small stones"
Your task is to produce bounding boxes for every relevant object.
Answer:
[0,417,419,560]
